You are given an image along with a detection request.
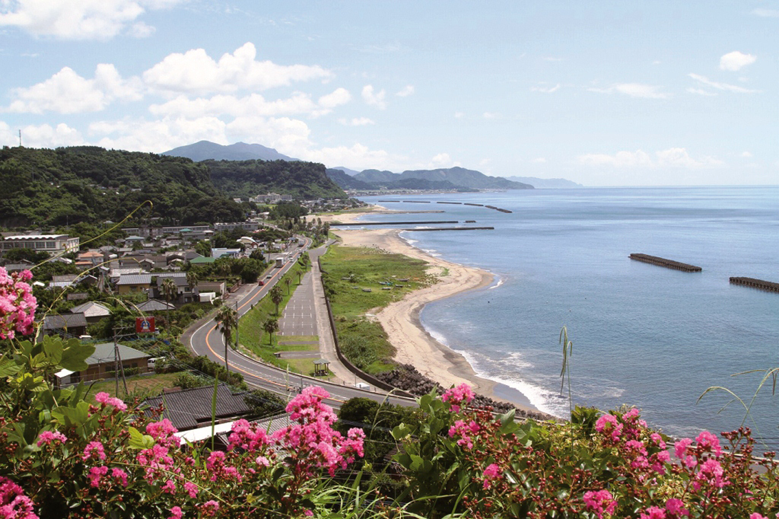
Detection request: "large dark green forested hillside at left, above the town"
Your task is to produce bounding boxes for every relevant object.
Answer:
[0,146,243,227]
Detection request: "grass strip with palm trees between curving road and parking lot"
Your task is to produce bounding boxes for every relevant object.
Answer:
[238,263,319,368]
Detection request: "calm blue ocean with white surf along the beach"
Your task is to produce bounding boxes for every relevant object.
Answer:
[362,186,779,448]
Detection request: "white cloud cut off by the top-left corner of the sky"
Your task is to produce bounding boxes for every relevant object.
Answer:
[0,0,182,40]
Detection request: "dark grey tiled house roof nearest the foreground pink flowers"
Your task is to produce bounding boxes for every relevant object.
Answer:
[144,384,252,437]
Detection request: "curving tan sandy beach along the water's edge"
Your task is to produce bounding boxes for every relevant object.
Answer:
[322,208,536,411]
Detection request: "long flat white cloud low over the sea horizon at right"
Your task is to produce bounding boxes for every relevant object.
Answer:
[578,148,724,169]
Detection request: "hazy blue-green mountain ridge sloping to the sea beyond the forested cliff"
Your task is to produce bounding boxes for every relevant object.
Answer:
[354,167,533,189]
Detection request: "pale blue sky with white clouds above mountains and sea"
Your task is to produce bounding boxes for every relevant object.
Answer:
[0,0,779,186]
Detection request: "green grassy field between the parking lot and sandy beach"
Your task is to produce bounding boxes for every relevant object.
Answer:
[322,247,436,373]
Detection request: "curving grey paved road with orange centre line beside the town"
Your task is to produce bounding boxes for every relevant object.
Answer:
[189,240,416,407]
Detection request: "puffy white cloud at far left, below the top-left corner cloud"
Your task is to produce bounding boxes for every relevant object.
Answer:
[3,64,142,114]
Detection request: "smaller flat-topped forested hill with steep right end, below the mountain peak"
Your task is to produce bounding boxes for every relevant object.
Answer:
[209,160,348,200]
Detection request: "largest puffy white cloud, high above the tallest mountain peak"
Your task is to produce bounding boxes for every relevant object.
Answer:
[143,42,333,94]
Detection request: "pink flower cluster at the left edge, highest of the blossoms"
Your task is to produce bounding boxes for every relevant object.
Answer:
[0,267,38,339]
